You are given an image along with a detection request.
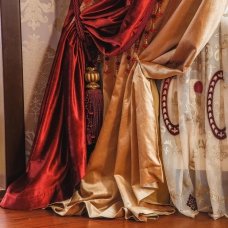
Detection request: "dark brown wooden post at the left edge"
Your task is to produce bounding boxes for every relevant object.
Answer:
[1,0,25,185]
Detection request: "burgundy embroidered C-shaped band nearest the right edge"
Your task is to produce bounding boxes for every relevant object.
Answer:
[207,70,227,140]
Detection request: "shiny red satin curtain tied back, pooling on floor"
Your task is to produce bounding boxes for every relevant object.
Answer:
[0,0,154,209]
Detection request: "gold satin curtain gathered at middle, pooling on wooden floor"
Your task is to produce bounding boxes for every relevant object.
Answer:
[51,0,226,221]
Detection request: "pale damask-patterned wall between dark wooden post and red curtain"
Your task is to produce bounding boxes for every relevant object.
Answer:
[21,0,69,158]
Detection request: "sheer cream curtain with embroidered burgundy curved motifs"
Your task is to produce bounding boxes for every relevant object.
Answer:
[161,8,228,219]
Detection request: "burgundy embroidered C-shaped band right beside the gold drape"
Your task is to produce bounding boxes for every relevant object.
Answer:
[161,77,180,135]
